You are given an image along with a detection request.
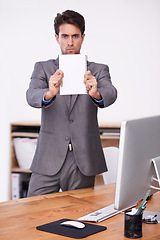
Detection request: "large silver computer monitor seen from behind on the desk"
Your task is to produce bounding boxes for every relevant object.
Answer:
[115,116,160,210]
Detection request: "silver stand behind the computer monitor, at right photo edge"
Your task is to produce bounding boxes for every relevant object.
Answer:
[150,156,160,190]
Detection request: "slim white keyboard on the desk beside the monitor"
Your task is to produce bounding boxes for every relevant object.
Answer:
[78,204,122,222]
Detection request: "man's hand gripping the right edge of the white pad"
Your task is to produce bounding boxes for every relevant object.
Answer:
[84,71,102,100]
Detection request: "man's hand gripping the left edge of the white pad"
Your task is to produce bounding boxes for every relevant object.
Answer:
[45,69,64,100]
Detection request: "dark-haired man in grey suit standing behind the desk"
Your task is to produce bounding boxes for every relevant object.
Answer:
[27,10,117,196]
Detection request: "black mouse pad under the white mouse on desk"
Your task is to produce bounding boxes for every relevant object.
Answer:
[36,218,107,239]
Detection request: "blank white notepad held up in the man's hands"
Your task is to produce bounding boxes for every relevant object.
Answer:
[59,54,87,95]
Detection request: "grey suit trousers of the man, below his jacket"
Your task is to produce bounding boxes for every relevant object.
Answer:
[28,151,95,197]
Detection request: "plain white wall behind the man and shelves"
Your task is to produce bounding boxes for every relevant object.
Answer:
[0,0,160,201]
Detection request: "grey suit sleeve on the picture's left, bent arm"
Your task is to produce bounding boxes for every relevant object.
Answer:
[26,63,49,108]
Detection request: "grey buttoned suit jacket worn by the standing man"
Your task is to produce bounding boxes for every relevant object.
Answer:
[27,59,117,176]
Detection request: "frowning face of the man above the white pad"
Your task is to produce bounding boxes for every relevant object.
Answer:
[55,23,85,54]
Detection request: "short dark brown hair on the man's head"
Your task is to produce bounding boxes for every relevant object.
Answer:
[54,10,85,35]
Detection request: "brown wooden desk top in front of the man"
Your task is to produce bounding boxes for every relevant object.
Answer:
[0,184,160,240]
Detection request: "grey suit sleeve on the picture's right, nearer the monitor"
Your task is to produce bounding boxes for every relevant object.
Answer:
[97,65,117,107]
